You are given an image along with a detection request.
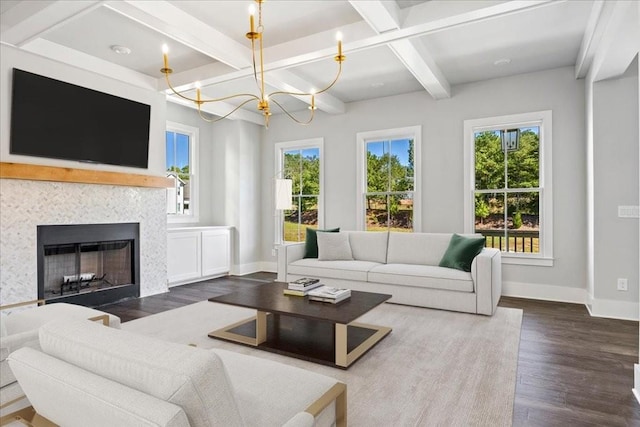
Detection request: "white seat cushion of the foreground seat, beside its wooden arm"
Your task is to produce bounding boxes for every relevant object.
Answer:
[211,349,338,426]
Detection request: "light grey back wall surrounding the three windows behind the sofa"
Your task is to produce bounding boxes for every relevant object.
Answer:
[262,67,586,302]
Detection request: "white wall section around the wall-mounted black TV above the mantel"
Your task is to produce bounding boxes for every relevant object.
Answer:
[0,45,166,176]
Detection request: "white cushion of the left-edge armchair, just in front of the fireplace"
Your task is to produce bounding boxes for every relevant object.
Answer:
[4,303,120,335]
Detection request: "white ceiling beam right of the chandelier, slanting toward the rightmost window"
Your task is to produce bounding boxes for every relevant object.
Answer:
[350,0,451,99]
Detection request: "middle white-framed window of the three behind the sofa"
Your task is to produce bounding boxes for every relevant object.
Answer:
[357,126,422,232]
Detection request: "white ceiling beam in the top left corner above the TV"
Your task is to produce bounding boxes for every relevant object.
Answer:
[0,0,103,47]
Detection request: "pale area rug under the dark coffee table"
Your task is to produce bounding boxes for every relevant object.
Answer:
[122,301,522,427]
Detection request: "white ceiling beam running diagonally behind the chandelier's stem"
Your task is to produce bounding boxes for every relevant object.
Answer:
[107,0,345,113]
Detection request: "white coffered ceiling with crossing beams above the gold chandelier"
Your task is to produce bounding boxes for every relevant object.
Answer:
[0,0,602,124]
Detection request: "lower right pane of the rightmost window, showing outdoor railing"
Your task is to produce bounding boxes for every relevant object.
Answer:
[505,191,540,253]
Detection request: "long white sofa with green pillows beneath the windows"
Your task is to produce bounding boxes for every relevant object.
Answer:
[278,231,502,315]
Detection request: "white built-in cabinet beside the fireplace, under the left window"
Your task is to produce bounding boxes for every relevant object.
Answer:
[167,227,231,286]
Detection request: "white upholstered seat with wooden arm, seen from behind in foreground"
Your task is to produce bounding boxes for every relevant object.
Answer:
[9,320,346,427]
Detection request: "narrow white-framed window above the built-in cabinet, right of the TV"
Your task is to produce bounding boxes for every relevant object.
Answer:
[165,122,198,222]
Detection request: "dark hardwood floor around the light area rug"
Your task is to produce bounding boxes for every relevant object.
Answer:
[100,273,640,426]
